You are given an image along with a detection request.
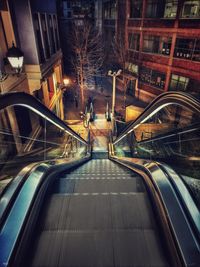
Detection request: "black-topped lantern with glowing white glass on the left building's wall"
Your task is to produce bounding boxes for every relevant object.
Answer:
[0,43,24,94]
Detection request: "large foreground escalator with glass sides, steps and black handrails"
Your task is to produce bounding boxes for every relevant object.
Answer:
[0,93,200,267]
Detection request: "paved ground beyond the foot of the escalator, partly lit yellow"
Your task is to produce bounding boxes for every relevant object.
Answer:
[64,78,145,152]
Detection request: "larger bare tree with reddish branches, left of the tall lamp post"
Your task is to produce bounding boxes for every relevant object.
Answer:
[72,20,104,109]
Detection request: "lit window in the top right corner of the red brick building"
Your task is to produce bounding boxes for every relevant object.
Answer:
[182,1,200,18]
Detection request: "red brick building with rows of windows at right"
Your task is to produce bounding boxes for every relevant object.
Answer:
[102,0,200,102]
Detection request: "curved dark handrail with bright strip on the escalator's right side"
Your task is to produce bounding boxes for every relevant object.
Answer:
[113,92,200,147]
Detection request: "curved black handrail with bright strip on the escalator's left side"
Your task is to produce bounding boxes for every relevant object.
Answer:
[0,92,88,145]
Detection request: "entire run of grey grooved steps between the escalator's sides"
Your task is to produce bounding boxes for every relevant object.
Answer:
[26,159,169,267]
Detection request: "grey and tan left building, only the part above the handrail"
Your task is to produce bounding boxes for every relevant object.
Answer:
[0,0,63,118]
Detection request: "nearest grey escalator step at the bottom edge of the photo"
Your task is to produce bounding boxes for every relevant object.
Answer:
[31,229,167,267]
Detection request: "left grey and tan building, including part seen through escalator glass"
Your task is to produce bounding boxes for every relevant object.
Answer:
[0,0,64,158]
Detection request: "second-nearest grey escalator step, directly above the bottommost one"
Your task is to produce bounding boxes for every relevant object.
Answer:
[41,193,155,230]
